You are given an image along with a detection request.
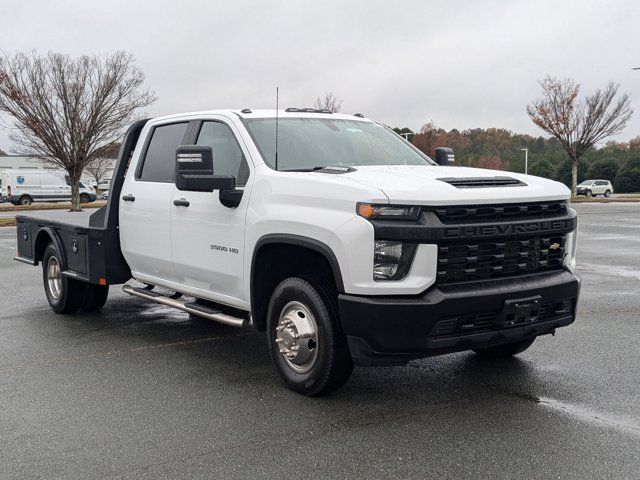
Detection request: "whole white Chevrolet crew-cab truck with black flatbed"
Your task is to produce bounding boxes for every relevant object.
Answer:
[16,108,580,395]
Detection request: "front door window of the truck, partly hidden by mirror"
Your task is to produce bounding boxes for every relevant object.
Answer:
[197,122,249,186]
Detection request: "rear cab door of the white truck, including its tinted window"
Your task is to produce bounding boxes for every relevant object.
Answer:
[120,121,188,287]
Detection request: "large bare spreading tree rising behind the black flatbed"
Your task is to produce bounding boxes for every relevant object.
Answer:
[0,52,156,211]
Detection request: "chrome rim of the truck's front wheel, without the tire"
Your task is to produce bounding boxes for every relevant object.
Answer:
[276,301,318,373]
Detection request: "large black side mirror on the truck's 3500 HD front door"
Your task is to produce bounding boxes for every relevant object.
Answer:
[176,145,236,192]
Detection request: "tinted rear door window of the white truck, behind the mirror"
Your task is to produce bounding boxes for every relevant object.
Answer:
[139,123,188,183]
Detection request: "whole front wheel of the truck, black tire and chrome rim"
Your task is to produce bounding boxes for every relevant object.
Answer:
[267,277,353,396]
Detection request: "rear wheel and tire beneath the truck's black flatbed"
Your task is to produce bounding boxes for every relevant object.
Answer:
[42,242,87,313]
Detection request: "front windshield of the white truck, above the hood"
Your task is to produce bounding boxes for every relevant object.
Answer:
[245,118,435,170]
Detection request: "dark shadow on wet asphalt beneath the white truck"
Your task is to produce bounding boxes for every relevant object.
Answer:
[37,296,542,408]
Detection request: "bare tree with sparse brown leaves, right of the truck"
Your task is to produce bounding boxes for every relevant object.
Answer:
[527,77,633,197]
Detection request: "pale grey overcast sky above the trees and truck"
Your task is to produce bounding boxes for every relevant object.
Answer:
[0,0,640,150]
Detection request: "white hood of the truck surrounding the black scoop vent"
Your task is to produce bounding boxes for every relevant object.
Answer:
[339,165,571,205]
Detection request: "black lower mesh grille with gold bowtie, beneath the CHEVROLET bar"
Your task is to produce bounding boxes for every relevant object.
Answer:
[437,234,566,285]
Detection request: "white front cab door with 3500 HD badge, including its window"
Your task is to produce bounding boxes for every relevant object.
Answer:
[170,119,249,305]
